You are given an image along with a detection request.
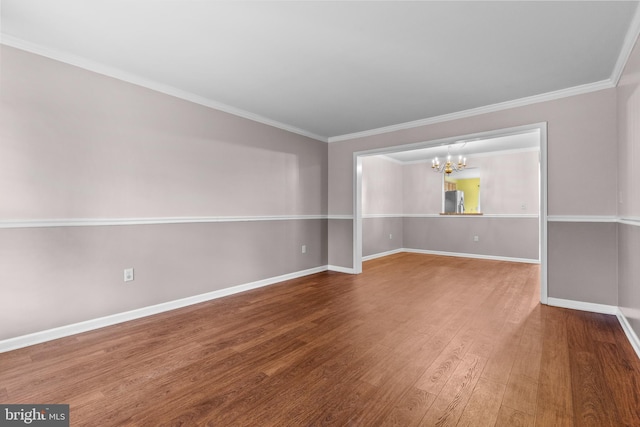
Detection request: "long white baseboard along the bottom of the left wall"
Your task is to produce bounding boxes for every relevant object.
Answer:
[0,265,328,353]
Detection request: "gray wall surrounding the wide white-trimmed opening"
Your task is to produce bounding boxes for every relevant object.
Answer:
[328,89,618,304]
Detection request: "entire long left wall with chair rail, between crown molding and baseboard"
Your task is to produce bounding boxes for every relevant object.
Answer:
[0,45,330,340]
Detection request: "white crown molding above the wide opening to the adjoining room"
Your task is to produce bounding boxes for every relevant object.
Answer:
[328,79,615,143]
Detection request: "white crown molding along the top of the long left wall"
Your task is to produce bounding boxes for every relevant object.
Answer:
[0,33,328,142]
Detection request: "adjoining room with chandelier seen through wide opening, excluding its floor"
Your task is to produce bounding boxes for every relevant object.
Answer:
[356,129,546,263]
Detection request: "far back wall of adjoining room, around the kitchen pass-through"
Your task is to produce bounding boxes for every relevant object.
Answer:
[403,151,540,262]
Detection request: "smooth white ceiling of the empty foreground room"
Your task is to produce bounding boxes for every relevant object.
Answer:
[0,0,640,141]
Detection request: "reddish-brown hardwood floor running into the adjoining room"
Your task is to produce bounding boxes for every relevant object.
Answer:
[0,253,640,427]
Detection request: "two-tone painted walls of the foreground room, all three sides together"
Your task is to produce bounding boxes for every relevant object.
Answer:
[0,34,640,352]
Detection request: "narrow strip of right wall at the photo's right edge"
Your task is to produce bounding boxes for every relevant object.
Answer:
[617,35,640,336]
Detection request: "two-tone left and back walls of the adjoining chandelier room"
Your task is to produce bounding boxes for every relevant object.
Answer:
[362,150,539,262]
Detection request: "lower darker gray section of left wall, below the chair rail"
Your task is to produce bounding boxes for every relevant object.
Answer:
[0,220,327,339]
